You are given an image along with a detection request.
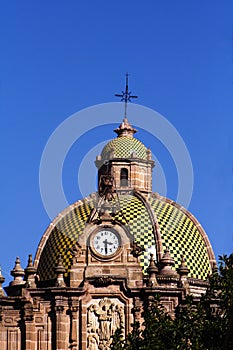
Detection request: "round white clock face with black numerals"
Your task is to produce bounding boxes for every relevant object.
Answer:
[93,229,120,256]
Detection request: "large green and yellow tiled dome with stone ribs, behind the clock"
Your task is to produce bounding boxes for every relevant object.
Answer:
[35,193,215,281]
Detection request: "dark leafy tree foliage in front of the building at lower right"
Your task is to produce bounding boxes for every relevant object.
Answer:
[111,254,233,350]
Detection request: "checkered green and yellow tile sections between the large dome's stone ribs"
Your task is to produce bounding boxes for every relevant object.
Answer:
[38,195,210,280]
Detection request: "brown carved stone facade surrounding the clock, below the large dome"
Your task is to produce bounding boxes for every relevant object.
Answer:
[0,232,207,350]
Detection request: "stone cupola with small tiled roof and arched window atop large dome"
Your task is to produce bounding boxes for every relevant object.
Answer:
[95,117,154,194]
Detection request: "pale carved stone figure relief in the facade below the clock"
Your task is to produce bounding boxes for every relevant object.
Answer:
[87,298,125,350]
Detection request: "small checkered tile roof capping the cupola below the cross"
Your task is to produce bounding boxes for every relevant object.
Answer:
[101,136,147,159]
